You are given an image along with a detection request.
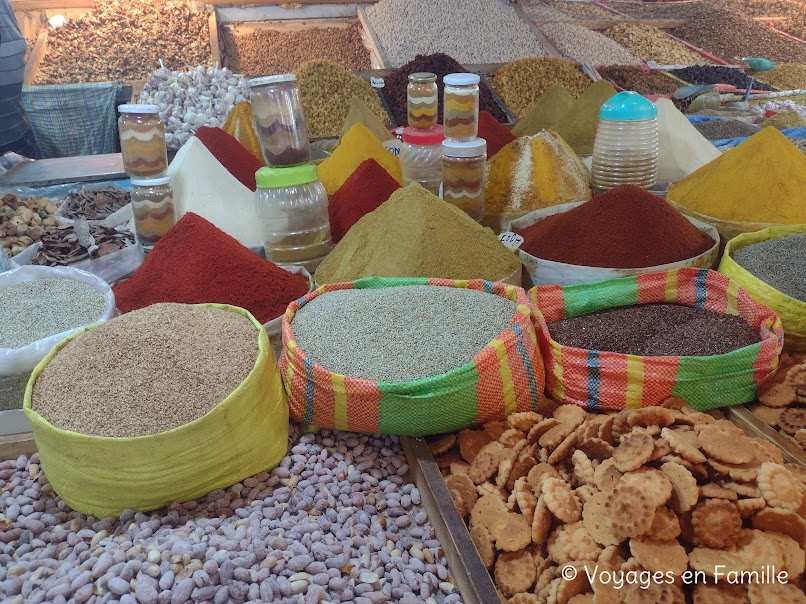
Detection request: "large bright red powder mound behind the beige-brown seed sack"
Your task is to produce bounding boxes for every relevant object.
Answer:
[114,212,308,323]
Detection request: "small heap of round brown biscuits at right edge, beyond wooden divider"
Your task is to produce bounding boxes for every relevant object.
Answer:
[750,354,806,451]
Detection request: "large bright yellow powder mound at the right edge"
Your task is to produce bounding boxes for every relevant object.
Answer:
[667,127,806,224]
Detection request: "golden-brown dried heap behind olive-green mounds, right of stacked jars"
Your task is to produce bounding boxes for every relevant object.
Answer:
[492,58,591,118]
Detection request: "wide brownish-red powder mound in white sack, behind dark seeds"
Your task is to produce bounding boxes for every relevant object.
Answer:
[513,185,714,268]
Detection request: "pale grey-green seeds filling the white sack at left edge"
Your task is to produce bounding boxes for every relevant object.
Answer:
[0,278,105,350]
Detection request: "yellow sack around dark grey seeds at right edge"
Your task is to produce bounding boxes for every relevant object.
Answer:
[719,224,806,353]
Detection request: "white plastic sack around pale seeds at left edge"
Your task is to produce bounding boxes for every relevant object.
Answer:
[0,266,117,377]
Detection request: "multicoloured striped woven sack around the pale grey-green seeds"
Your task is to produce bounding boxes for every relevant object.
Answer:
[280,277,545,436]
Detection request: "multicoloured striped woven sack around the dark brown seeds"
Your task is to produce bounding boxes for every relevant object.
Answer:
[529,268,784,411]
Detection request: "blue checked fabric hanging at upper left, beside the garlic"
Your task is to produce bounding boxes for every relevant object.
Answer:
[22,82,121,158]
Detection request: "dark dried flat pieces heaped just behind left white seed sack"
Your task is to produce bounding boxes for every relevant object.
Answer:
[31,218,136,266]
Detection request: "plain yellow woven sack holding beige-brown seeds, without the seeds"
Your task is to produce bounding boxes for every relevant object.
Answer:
[24,304,288,518]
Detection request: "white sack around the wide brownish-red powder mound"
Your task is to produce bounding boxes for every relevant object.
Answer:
[507,201,719,285]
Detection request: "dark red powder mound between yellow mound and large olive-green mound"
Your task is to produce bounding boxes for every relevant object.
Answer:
[327,159,400,243]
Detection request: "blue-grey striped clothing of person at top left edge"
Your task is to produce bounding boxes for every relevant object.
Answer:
[0,0,38,159]
